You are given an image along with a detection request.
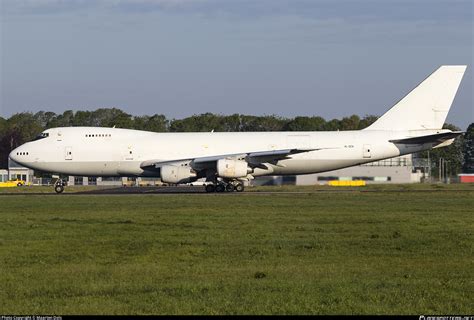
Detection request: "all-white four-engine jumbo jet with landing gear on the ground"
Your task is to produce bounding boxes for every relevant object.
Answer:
[9,65,467,193]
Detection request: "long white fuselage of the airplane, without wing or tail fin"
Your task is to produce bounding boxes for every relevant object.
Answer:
[10,127,446,176]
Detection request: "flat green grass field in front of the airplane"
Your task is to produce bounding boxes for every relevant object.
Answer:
[0,185,474,314]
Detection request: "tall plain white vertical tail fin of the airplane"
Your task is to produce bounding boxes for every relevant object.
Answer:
[366,66,466,130]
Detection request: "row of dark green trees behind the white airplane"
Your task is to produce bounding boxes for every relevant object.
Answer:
[0,108,474,178]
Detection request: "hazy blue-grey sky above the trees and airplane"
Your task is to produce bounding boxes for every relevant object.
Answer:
[0,0,474,129]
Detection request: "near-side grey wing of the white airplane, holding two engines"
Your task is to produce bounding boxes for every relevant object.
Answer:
[140,149,320,170]
